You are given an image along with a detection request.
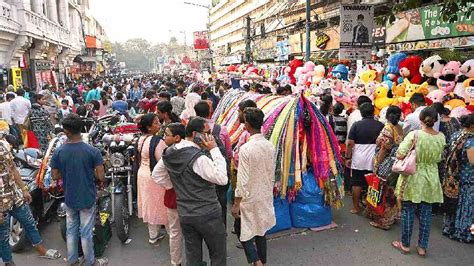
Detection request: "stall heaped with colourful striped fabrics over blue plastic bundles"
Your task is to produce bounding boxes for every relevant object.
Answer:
[213,90,344,231]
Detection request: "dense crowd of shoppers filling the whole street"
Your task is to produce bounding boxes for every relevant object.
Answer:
[0,69,474,265]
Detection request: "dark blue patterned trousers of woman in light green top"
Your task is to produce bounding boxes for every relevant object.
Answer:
[401,201,432,249]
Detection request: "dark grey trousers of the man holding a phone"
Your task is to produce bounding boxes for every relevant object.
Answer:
[179,210,227,266]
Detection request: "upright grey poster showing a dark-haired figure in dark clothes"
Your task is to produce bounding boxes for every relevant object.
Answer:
[339,5,374,60]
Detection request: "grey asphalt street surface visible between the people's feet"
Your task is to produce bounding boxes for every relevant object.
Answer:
[14,197,474,266]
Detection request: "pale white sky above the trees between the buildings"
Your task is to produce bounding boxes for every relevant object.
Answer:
[90,0,211,45]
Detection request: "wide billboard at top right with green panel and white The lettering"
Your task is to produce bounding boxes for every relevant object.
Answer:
[386,3,474,43]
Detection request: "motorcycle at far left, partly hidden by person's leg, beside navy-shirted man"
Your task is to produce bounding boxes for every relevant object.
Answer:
[9,142,63,252]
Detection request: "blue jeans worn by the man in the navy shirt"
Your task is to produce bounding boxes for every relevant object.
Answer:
[66,205,96,266]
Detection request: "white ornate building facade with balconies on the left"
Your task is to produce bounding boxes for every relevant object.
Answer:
[0,0,105,90]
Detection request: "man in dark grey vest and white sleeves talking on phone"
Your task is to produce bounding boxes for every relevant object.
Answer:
[152,117,228,265]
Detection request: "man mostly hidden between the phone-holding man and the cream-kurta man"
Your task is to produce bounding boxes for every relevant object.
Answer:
[194,101,232,225]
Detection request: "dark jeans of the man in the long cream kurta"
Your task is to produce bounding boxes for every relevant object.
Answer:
[234,218,267,264]
